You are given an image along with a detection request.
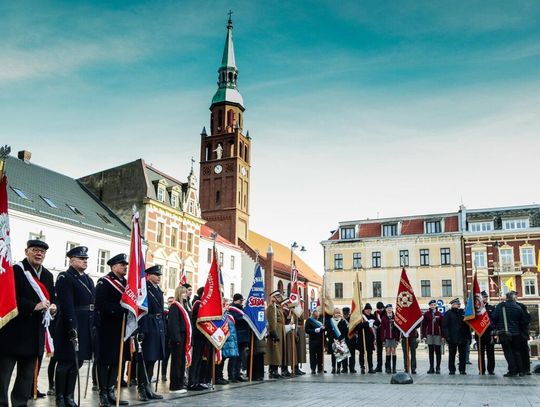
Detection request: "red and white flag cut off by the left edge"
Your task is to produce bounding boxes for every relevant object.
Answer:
[0,175,19,329]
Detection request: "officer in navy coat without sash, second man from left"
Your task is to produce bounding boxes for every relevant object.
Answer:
[54,246,95,407]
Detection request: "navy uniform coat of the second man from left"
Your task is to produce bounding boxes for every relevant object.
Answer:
[54,267,96,361]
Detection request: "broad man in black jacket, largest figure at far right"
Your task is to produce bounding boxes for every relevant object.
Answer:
[492,291,526,377]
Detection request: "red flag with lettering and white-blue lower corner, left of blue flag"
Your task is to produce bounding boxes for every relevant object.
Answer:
[197,251,229,350]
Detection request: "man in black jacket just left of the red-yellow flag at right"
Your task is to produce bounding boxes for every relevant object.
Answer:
[443,298,471,375]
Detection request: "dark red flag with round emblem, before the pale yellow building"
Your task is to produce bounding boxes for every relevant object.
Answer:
[394,267,424,337]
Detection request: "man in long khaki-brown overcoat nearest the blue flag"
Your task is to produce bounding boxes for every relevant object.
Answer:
[265,290,285,379]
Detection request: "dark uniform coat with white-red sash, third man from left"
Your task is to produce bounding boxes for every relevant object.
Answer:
[95,271,129,365]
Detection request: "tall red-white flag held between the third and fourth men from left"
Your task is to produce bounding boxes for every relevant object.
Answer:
[120,212,148,339]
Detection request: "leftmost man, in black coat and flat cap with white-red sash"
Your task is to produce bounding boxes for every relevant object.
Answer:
[0,240,56,406]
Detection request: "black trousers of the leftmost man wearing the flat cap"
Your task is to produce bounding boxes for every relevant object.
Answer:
[0,355,37,407]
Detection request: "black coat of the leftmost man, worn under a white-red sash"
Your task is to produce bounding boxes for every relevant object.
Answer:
[0,259,56,356]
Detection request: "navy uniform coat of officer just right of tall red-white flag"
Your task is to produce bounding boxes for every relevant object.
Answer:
[138,281,165,362]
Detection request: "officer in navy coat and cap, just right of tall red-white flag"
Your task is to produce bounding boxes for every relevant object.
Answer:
[137,264,165,401]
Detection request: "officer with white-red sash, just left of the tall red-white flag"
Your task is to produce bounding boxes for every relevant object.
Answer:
[96,253,129,407]
